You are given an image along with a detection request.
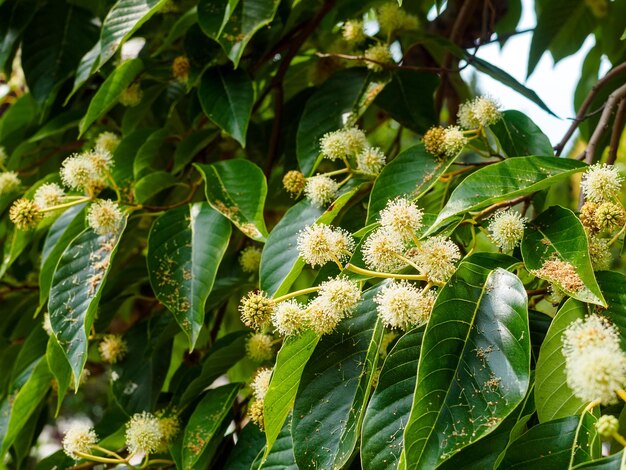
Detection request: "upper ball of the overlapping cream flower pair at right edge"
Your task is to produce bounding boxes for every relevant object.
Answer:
[562,315,620,358]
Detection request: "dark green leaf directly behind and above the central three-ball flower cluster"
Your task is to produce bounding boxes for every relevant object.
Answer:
[367,143,454,224]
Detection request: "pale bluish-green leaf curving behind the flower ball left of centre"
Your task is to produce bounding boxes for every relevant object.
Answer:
[259,187,359,296]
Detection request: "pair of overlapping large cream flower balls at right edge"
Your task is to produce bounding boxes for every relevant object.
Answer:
[562,315,626,405]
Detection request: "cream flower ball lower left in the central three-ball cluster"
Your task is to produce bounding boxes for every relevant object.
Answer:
[362,227,406,272]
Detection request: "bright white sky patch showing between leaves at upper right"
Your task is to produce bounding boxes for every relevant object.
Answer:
[462,0,594,149]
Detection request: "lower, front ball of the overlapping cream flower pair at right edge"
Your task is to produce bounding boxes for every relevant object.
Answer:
[565,346,626,405]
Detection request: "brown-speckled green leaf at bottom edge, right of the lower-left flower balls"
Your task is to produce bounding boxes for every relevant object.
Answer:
[183,384,239,470]
